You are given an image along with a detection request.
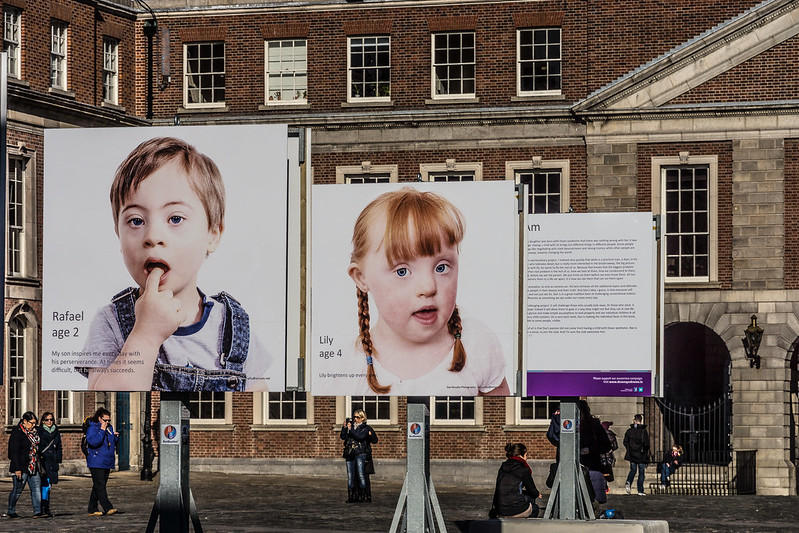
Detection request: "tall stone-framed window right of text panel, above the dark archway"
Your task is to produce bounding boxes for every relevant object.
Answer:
[652,153,718,282]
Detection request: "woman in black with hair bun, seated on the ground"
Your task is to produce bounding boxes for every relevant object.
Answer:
[488,442,541,518]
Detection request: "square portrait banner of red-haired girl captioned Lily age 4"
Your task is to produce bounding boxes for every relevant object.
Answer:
[309,181,518,396]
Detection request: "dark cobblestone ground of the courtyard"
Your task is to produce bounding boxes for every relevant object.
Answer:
[0,472,799,533]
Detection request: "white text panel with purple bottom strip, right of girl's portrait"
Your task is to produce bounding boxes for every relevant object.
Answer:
[525,213,656,396]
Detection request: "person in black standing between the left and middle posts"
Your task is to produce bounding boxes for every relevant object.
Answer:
[340,409,377,503]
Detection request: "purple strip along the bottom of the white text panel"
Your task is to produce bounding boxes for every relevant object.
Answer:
[527,371,652,396]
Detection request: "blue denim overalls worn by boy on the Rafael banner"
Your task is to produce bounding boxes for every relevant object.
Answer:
[111,287,250,392]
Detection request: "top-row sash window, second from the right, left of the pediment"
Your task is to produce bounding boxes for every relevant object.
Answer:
[432,32,475,98]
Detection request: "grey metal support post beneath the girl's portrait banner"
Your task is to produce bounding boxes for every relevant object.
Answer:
[389,396,447,533]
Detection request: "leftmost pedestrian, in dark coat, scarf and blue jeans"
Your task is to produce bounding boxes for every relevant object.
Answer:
[4,411,42,518]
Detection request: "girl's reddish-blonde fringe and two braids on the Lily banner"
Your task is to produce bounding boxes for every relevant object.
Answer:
[351,187,466,394]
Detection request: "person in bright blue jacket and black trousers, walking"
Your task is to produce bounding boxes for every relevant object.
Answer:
[86,407,119,516]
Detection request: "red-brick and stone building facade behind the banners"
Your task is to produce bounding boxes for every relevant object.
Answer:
[0,0,799,494]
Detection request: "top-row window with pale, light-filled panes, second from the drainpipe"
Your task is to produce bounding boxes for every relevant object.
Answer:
[265,39,308,105]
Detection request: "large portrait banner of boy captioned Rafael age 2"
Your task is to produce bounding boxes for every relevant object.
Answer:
[42,125,288,392]
